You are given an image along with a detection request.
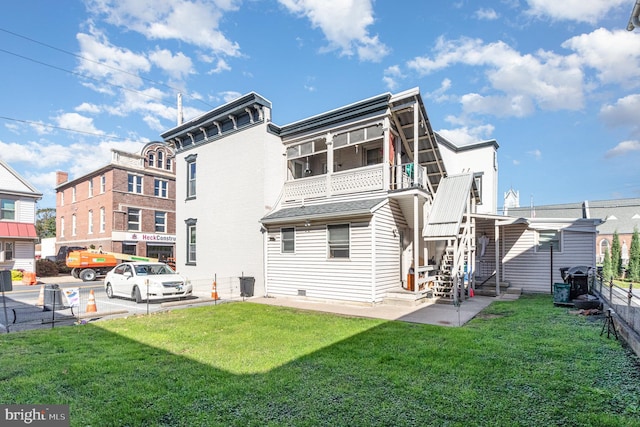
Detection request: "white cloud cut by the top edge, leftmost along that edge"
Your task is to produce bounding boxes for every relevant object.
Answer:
[87,0,240,56]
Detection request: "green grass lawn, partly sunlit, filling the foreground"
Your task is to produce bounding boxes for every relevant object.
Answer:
[0,295,640,427]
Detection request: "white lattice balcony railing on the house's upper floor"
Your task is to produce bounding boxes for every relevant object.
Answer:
[284,163,426,201]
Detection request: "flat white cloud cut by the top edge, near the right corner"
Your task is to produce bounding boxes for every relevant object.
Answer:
[527,0,633,24]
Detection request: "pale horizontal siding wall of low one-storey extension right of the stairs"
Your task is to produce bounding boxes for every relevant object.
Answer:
[500,225,596,293]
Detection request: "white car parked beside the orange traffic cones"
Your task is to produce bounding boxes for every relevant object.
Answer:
[104,262,193,302]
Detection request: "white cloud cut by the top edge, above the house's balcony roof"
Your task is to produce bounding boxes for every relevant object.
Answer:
[278,0,389,62]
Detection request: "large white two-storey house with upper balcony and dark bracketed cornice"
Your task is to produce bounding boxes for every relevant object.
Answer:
[162,88,595,304]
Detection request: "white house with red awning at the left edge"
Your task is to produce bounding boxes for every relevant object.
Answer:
[0,160,42,272]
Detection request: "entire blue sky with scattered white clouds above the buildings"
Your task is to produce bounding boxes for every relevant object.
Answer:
[0,0,640,208]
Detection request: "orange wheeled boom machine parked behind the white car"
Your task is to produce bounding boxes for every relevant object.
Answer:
[66,250,158,282]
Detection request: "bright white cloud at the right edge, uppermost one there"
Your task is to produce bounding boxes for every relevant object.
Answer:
[562,28,640,87]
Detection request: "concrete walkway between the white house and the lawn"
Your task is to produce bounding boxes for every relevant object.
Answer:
[247,294,515,326]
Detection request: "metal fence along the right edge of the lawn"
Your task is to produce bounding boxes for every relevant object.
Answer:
[591,274,640,334]
